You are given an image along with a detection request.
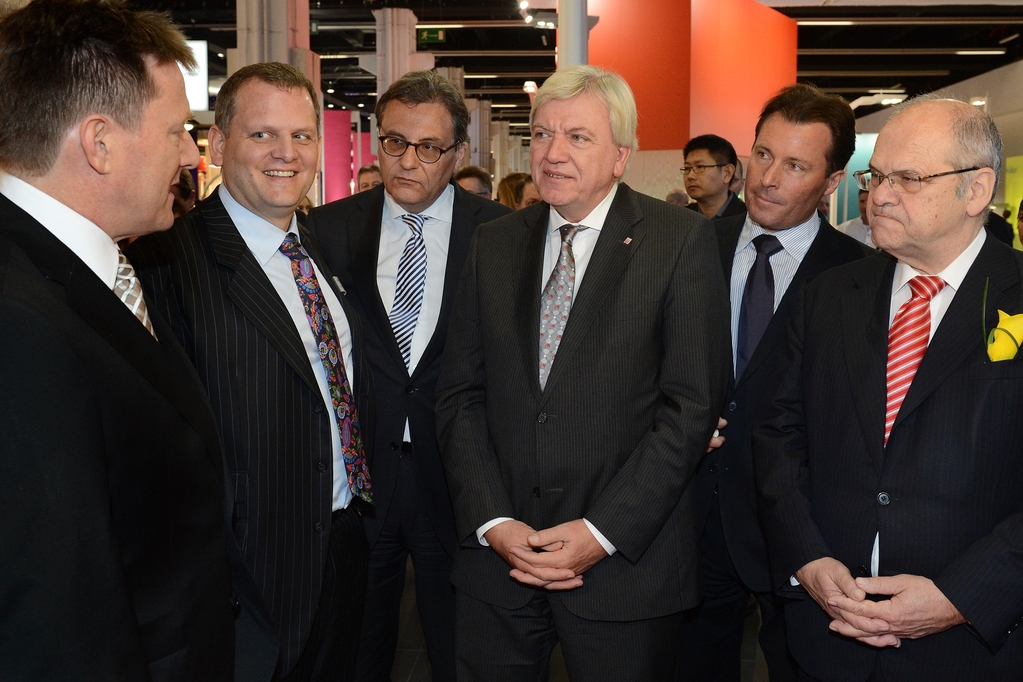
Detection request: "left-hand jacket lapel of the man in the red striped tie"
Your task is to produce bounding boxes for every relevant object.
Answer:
[836,257,895,473]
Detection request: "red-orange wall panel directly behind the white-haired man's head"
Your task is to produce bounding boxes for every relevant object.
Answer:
[587,0,691,150]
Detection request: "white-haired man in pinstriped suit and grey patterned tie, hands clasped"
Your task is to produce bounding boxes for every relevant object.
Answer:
[437,66,728,681]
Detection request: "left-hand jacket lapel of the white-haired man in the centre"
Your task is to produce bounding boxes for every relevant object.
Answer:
[508,203,561,399]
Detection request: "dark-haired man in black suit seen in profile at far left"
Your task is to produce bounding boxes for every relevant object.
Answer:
[0,0,233,682]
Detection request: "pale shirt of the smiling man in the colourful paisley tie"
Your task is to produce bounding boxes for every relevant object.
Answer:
[220,184,354,510]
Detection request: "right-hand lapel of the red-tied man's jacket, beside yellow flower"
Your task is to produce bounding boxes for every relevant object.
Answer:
[892,236,1020,433]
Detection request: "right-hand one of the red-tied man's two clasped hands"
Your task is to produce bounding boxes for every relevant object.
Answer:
[832,575,966,646]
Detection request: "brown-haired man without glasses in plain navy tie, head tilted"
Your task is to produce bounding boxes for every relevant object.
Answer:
[677,85,868,682]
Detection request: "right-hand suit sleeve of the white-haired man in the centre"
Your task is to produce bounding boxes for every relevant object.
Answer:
[585,216,731,561]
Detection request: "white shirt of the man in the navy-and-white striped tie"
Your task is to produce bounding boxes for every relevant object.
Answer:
[376,184,454,442]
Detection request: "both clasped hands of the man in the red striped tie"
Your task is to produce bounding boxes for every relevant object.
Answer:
[796,557,966,647]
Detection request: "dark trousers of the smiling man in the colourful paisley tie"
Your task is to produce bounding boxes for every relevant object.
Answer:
[281,500,369,682]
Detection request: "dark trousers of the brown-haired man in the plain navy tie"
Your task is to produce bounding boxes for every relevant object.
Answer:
[675,492,798,682]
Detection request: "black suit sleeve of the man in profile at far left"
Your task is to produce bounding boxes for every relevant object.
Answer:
[0,300,149,682]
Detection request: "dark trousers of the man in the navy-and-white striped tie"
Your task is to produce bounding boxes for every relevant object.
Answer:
[355,452,455,682]
